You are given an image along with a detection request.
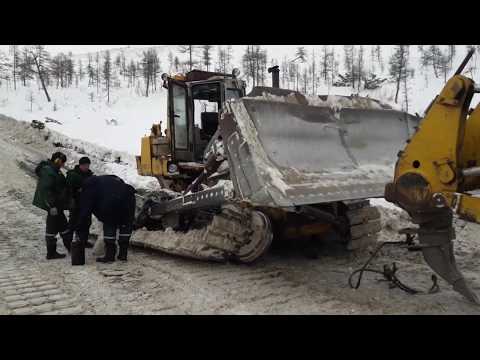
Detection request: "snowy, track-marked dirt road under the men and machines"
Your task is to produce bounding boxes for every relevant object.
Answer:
[0,117,480,314]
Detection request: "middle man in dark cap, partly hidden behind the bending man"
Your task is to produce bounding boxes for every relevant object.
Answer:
[66,157,93,248]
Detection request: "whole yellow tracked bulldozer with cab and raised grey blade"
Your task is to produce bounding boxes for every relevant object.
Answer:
[132,66,419,263]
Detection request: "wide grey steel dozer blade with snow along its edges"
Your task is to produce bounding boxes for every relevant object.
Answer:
[220,93,419,207]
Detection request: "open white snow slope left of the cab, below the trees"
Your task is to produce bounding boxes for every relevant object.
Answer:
[0,86,167,155]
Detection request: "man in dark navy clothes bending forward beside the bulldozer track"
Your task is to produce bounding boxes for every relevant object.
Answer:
[75,175,135,263]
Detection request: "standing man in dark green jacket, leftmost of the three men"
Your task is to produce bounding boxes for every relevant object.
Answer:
[33,152,72,260]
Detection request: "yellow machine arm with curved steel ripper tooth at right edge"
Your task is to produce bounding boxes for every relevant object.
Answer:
[385,50,480,304]
